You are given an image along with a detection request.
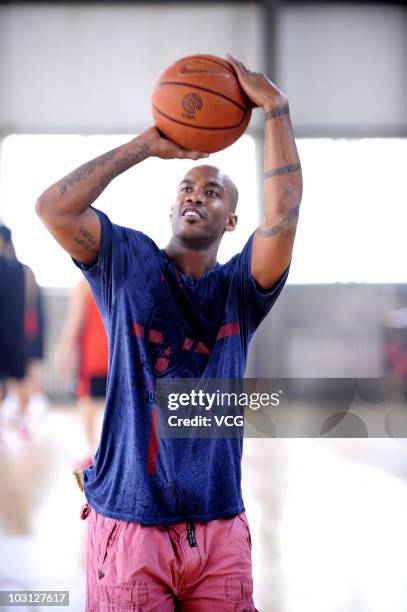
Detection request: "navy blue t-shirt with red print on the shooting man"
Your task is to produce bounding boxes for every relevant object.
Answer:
[76,211,288,525]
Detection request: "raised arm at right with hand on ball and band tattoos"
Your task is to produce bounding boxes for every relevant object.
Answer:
[228,56,302,289]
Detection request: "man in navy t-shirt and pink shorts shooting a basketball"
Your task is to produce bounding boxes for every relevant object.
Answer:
[37,56,302,612]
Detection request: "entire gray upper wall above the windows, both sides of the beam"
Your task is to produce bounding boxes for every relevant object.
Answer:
[0,2,407,136]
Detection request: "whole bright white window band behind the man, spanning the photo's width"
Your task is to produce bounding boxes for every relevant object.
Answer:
[0,135,407,287]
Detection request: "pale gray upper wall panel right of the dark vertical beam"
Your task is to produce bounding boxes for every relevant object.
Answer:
[276,3,407,136]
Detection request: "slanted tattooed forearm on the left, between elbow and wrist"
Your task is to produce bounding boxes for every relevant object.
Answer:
[37,133,150,217]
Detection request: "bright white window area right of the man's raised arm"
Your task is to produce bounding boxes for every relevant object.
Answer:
[290,138,407,283]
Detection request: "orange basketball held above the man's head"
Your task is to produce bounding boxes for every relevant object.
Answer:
[151,55,252,153]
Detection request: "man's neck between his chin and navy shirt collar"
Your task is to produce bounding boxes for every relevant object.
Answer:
[165,236,219,278]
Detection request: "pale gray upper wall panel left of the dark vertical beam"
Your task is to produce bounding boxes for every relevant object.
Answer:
[0,3,262,133]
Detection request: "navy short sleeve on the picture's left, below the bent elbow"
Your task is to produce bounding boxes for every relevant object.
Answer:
[73,209,157,318]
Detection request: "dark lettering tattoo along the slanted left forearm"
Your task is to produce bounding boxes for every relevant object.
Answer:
[57,143,149,196]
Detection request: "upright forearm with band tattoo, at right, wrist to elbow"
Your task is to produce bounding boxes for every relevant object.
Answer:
[258,103,302,233]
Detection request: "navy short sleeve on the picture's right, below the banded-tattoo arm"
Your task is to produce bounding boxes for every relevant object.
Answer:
[226,234,290,335]
